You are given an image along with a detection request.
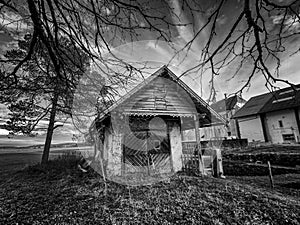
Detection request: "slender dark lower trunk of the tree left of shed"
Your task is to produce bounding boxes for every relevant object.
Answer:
[41,93,58,165]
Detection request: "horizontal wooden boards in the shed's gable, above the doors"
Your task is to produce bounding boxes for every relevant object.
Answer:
[118,77,197,115]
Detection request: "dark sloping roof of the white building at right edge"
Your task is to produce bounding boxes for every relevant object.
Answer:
[233,85,300,118]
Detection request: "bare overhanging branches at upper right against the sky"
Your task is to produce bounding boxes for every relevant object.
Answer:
[174,0,300,100]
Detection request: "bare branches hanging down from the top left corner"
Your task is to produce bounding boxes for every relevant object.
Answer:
[1,0,184,82]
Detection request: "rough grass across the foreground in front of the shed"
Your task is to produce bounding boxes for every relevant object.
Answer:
[0,157,300,224]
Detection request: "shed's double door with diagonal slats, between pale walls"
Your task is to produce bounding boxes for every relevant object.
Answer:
[122,118,172,176]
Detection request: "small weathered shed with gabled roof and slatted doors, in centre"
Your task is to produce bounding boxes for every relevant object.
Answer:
[94,66,225,180]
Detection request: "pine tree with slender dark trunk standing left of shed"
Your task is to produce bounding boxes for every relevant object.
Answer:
[0,34,89,163]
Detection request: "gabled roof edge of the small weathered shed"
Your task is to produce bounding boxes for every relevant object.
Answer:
[98,66,225,127]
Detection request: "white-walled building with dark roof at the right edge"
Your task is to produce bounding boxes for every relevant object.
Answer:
[233,85,300,143]
